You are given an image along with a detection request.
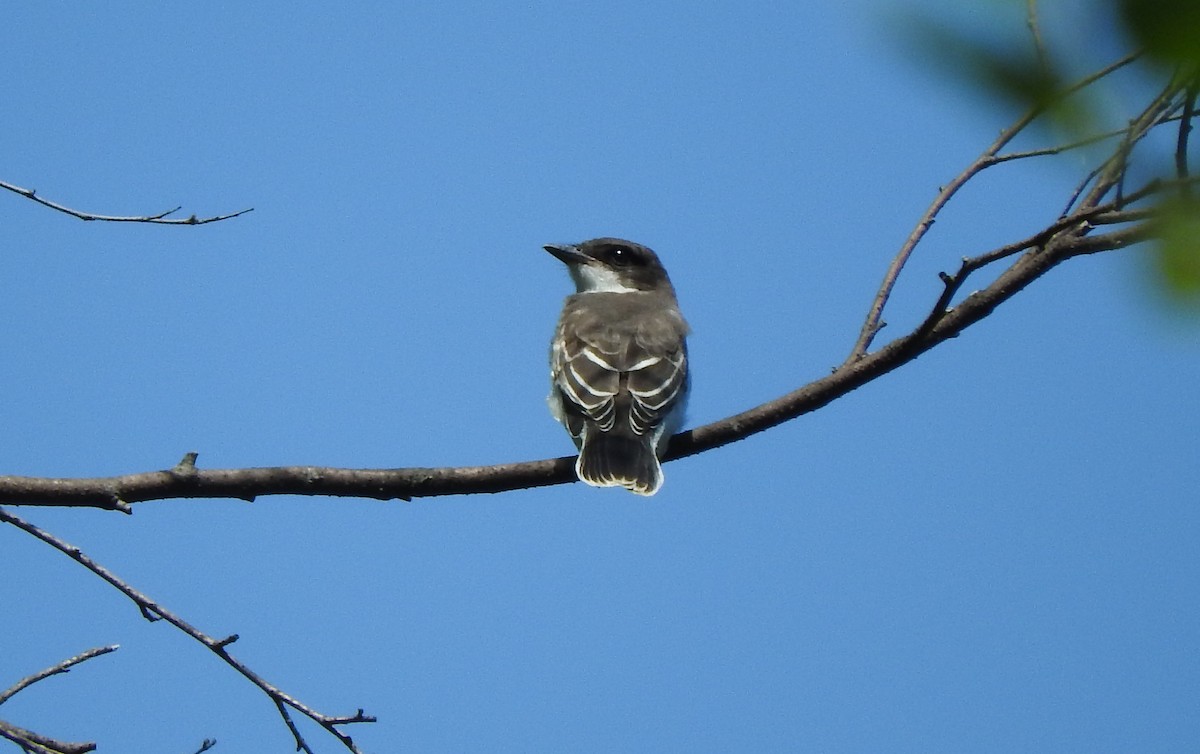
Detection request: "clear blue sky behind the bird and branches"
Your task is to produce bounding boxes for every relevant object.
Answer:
[0,0,1200,753]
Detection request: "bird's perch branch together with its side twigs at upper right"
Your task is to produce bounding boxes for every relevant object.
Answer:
[0,56,1192,513]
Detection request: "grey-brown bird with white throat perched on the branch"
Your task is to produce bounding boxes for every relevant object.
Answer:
[544,238,690,496]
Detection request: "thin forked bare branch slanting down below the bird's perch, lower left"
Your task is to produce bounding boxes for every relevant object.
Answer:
[0,508,376,754]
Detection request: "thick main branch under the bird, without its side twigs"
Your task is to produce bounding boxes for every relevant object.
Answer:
[0,223,1150,513]
